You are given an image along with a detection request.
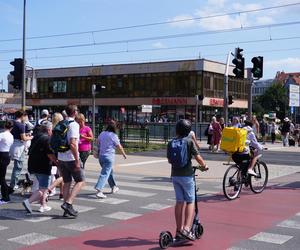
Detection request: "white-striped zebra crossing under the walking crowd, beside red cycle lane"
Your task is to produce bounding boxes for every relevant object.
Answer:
[0,171,174,249]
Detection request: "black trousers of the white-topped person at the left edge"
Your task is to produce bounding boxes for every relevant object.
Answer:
[0,152,12,201]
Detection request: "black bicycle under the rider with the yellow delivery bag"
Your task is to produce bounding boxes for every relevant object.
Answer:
[223,149,268,200]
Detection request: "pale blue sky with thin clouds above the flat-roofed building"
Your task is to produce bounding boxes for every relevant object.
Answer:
[0,0,300,90]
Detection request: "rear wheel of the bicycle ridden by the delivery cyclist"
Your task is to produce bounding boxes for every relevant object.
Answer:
[223,164,242,200]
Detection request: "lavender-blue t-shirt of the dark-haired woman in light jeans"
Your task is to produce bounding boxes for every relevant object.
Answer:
[98,131,120,156]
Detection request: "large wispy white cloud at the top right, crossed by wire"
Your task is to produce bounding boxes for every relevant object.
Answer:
[171,0,300,30]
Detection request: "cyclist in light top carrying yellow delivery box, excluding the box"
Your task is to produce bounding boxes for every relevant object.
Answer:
[232,120,263,176]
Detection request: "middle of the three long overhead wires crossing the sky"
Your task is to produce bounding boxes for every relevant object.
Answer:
[0,21,300,54]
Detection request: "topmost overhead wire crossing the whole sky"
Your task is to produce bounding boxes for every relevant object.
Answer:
[0,2,300,42]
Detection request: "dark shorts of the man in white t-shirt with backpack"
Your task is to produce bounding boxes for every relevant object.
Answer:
[58,161,85,183]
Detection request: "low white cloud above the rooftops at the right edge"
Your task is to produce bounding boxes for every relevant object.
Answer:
[264,57,300,72]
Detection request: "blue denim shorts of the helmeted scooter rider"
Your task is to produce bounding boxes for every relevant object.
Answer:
[172,176,195,203]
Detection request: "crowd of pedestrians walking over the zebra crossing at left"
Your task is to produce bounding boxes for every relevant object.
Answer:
[0,105,127,217]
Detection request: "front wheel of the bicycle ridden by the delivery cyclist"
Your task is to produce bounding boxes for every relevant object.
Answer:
[250,161,269,194]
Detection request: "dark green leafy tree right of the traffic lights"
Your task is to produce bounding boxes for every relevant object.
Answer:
[253,83,289,120]
